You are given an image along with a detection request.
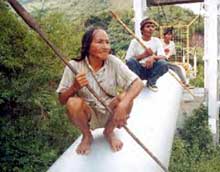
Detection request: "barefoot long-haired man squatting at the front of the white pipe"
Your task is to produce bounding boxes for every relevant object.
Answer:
[57,28,143,155]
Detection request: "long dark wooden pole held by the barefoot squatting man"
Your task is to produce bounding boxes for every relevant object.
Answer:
[8,0,168,172]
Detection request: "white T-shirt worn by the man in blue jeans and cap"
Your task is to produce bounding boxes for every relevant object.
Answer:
[125,37,165,63]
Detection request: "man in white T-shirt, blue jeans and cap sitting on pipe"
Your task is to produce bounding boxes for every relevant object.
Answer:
[126,18,168,91]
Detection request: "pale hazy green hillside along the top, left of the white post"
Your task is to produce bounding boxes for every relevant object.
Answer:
[19,0,132,20]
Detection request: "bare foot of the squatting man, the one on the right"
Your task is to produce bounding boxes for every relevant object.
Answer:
[104,132,123,152]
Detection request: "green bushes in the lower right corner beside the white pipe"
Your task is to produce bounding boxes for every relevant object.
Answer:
[169,106,220,172]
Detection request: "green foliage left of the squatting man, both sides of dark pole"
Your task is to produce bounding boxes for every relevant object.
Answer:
[0,1,82,172]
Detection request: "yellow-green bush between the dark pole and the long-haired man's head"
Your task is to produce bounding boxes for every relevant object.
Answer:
[41,13,84,59]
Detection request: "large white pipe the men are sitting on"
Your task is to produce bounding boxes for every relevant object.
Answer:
[48,74,182,172]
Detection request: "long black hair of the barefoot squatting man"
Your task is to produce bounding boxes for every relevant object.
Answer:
[75,27,102,61]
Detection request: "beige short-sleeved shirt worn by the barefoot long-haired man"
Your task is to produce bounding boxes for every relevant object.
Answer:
[57,55,138,112]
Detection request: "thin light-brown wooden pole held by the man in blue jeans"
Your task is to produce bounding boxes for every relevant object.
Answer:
[110,11,195,98]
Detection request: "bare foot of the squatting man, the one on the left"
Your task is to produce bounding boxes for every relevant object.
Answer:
[76,135,93,155]
